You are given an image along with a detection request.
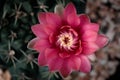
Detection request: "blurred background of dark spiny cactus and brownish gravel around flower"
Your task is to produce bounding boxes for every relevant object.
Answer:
[0,0,120,80]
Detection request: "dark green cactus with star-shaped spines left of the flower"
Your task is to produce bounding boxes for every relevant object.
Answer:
[0,0,86,80]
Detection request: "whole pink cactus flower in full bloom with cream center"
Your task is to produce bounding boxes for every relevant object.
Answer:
[28,3,108,76]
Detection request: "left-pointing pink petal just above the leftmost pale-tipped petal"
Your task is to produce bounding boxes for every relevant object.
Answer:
[32,24,48,38]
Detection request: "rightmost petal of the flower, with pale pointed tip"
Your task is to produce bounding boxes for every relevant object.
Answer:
[96,34,109,48]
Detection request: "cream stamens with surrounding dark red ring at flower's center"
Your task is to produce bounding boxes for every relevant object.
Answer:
[56,26,78,51]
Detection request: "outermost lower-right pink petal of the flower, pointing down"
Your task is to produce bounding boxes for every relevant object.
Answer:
[80,55,91,73]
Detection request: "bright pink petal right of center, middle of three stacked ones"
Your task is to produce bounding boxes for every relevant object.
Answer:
[81,30,97,41]
